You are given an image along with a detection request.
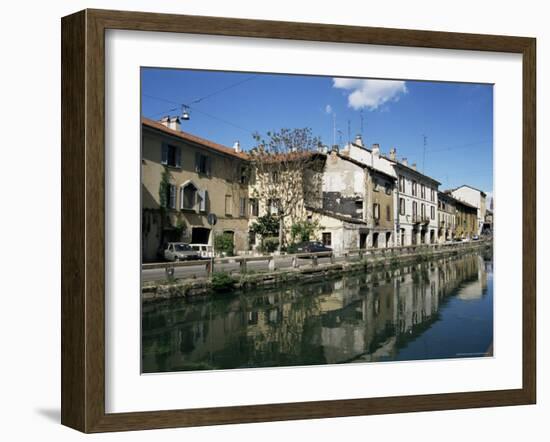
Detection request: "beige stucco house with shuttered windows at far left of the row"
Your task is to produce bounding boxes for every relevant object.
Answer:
[141,120,253,261]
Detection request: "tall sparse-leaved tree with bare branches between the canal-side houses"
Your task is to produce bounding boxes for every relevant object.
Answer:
[250,128,325,250]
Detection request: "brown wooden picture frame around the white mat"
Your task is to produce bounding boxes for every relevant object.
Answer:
[61,10,536,432]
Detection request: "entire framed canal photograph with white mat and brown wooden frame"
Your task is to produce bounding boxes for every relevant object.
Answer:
[62,10,536,432]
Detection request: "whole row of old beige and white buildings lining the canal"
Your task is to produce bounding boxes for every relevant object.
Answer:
[141,117,492,261]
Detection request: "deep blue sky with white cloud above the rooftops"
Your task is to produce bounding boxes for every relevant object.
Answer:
[141,68,493,193]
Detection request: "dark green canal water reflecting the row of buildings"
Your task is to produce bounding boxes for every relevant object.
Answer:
[142,253,493,373]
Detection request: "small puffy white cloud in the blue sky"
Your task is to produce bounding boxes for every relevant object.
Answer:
[332,78,407,110]
